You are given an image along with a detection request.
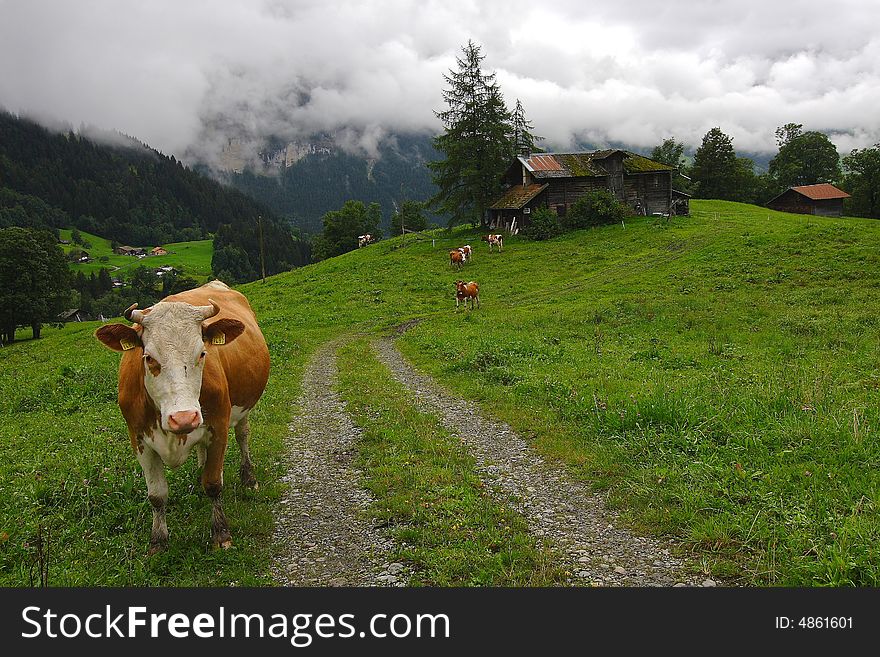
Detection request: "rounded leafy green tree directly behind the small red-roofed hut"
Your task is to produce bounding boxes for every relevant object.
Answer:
[768,123,840,189]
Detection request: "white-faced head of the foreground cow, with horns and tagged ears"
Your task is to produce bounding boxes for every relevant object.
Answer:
[96,301,244,434]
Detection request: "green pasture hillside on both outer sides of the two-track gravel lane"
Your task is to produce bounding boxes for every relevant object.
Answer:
[0,201,880,586]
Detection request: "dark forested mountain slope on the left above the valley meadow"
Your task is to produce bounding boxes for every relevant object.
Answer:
[0,111,308,280]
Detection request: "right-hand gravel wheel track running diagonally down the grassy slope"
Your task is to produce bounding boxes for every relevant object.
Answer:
[373,336,716,586]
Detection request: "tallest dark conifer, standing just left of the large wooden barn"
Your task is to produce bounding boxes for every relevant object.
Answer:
[428,41,515,226]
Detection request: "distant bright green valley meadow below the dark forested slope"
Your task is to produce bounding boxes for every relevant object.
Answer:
[58,229,214,282]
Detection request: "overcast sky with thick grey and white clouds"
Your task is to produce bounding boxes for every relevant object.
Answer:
[0,0,880,164]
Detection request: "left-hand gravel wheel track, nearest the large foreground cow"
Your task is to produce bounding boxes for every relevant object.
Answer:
[271,342,407,586]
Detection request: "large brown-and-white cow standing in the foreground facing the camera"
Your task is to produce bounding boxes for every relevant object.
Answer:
[95,281,269,554]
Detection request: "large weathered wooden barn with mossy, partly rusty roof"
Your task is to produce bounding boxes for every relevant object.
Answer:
[489,149,689,230]
